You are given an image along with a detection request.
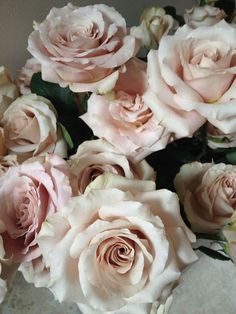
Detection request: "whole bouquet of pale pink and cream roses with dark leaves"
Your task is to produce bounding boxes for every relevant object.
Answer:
[0,1,236,314]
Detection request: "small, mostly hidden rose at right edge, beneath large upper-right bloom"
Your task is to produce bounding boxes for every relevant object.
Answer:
[207,123,236,149]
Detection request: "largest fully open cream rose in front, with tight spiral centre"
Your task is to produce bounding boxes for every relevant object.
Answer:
[38,184,196,313]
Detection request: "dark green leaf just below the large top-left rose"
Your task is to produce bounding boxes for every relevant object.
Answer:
[30,72,79,116]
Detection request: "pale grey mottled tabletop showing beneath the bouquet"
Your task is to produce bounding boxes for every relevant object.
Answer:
[0,255,236,314]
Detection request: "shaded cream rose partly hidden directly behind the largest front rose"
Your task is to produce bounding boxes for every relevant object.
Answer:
[69,139,155,194]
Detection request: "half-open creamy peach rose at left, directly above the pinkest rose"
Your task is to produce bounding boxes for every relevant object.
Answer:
[2,94,66,160]
